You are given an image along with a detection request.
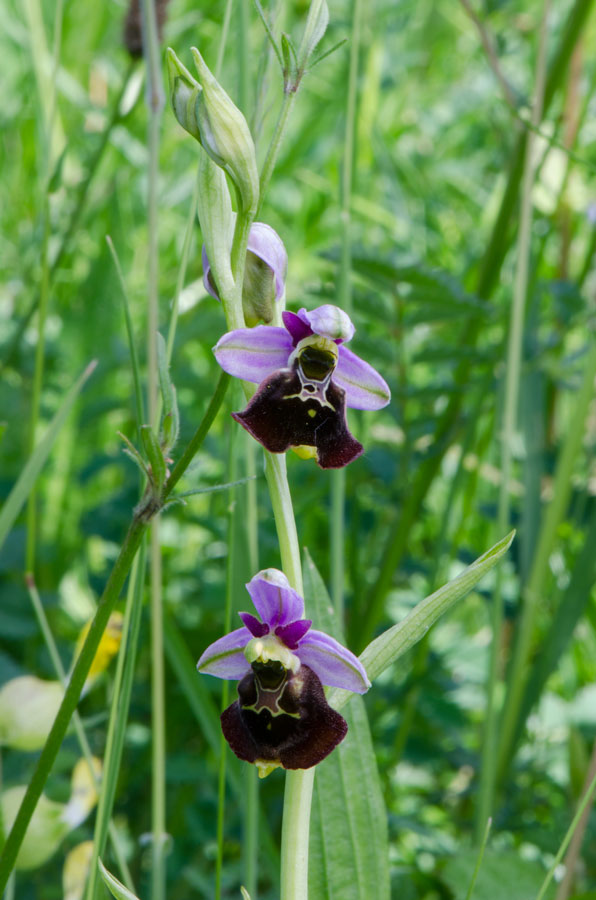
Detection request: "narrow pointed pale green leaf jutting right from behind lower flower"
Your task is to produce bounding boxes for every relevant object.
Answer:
[329,531,515,709]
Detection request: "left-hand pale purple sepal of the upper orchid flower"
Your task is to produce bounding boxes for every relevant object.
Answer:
[213,325,293,384]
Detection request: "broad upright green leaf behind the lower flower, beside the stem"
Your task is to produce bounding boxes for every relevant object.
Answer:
[304,551,390,900]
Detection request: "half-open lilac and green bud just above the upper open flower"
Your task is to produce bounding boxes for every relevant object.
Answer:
[202,222,288,325]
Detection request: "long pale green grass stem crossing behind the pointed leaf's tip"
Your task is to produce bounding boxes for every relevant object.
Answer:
[476,0,550,841]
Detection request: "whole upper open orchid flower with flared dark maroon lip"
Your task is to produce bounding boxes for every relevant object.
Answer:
[213,304,391,469]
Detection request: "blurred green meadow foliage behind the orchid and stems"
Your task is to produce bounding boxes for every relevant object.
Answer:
[0,0,596,900]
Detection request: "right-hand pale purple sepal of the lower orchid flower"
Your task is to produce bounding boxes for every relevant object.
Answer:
[296,629,370,694]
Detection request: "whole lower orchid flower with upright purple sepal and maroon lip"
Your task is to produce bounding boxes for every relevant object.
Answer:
[197,569,370,774]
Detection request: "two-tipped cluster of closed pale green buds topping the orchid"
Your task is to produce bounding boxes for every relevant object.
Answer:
[167,47,259,214]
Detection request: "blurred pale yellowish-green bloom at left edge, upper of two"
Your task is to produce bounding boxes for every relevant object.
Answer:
[0,675,64,750]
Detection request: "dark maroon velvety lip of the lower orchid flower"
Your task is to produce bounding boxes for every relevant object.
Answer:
[221,662,348,769]
